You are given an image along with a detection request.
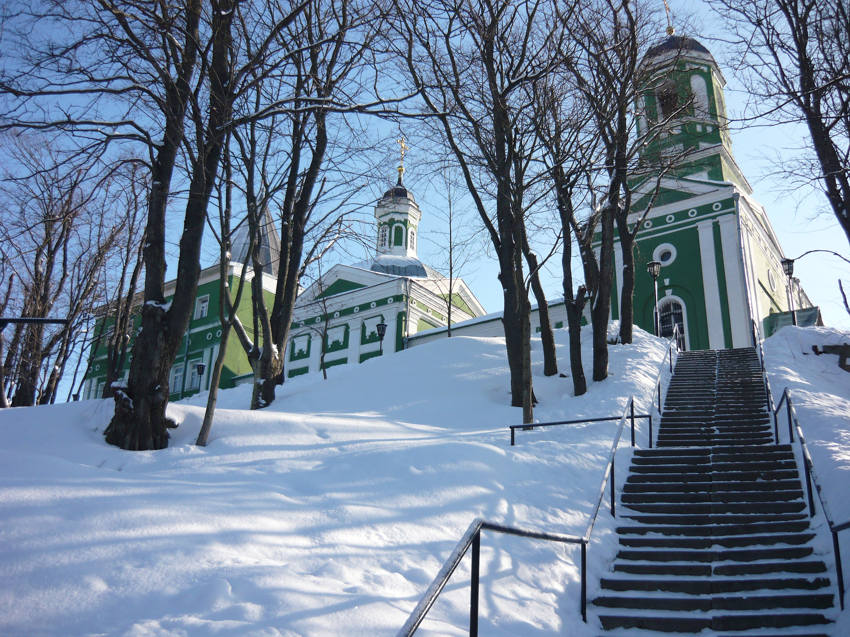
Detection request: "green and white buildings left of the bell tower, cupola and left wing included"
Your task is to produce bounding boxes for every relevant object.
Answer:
[82,166,484,400]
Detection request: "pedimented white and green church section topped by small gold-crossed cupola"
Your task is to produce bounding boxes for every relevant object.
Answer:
[284,167,484,378]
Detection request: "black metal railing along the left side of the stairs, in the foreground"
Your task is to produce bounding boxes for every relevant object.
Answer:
[398,396,640,637]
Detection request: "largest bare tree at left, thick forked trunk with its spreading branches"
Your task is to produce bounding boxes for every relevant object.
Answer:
[0,0,308,449]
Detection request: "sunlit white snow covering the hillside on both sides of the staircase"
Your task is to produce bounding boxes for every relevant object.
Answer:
[0,328,850,636]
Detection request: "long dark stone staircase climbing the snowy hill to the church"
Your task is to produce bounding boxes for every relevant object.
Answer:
[593,349,833,637]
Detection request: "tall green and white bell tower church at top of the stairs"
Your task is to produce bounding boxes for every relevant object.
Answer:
[611,36,817,349]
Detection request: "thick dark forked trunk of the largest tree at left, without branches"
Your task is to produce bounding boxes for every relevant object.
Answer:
[104,3,233,450]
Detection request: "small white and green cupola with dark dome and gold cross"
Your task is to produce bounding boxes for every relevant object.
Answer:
[375,138,422,258]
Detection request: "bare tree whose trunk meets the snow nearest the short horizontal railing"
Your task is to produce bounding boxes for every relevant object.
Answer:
[396,0,563,422]
